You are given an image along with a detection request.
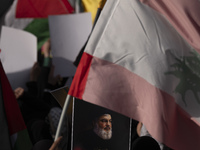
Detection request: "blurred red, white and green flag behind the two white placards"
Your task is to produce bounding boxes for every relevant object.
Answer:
[5,0,74,50]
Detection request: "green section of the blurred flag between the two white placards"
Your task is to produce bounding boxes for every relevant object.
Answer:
[24,18,50,50]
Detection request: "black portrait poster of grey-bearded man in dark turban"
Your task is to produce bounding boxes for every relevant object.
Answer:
[71,99,131,150]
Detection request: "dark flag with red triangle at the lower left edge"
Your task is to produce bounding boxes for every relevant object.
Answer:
[0,62,32,150]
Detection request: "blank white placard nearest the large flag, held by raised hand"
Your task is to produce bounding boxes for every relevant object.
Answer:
[48,13,92,76]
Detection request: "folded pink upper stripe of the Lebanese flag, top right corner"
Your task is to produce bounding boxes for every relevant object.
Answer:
[140,0,200,52]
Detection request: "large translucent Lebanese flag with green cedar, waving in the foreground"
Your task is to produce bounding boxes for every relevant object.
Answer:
[69,0,200,150]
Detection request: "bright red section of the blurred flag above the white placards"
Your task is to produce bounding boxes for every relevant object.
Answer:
[16,0,74,18]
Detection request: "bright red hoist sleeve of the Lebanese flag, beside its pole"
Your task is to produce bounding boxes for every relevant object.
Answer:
[68,53,93,99]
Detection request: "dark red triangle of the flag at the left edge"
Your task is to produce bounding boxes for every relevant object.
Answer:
[0,62,26,135]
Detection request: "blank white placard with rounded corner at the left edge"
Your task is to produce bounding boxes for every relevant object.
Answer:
[0,26,37,89]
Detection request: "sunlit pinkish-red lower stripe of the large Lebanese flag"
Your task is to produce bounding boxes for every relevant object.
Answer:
[81,57,200,150]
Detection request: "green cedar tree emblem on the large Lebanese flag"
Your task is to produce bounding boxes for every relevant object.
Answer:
[165,51,200,106]
